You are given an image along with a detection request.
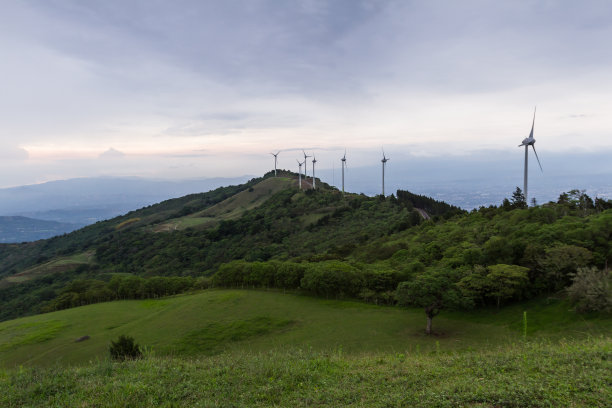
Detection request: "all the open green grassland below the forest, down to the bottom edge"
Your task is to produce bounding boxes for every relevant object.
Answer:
[0,290,612,407]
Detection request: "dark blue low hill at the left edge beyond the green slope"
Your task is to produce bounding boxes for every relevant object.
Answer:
[0,216,83,243]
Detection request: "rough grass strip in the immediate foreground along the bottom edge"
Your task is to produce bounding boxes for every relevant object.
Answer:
[0,338,612,407]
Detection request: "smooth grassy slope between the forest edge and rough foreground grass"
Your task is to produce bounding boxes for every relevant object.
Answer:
[0,290,612,367]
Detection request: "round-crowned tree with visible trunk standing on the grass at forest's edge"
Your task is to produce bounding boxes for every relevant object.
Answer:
[395,269,470,334]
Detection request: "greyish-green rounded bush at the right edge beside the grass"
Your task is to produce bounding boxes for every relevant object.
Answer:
[567,267,612,312]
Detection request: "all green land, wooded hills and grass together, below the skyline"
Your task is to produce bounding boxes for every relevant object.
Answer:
[0,172,612,407]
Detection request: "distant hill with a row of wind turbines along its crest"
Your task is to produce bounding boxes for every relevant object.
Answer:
[0,172,452,318]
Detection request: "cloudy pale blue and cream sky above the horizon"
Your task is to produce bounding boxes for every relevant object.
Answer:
[0,0,612,187]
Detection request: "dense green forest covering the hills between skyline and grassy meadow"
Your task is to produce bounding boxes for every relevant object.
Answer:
[0,173,612,326]
